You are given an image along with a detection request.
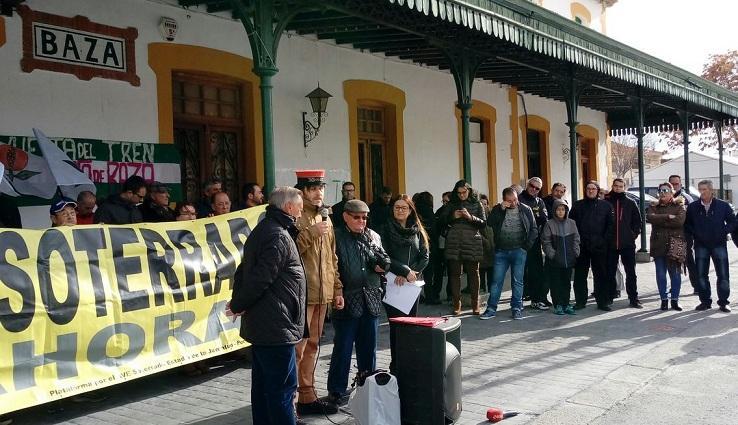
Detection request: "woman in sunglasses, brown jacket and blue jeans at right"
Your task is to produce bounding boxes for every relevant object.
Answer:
[646,182,687,311]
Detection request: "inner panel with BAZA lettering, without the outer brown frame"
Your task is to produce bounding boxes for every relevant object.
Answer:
[33,22,126,71]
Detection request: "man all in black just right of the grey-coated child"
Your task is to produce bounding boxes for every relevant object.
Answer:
[569,181,615,311]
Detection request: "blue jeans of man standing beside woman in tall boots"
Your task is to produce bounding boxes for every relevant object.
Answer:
[487,248,527,311]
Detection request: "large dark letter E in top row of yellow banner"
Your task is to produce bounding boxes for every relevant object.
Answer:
[108,227,150,312]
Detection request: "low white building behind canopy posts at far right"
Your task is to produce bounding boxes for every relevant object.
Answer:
[633,151,738,202]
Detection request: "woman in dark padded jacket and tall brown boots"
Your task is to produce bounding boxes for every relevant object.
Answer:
[445,180,486,315]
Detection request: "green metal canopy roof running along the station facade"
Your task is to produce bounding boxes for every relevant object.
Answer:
[179,0,738,128]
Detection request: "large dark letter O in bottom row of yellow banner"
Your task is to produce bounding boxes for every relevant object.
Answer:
[87,322,146,367]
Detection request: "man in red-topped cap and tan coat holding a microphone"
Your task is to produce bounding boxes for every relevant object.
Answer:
[295,170,343,416]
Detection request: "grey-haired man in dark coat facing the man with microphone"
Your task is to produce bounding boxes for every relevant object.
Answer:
[229,187,307,425]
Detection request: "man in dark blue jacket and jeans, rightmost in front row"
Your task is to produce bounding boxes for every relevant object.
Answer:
[684,180,738,313]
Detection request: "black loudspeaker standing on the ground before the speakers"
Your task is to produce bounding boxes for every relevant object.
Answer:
[390,317,461,425]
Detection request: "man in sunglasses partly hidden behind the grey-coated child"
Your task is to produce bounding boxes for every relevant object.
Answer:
[518,177,551,310]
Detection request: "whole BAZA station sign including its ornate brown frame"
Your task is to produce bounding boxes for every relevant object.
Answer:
[18,5,141,86]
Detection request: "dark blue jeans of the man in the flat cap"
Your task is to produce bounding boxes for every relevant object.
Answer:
[328,309,379,395]
